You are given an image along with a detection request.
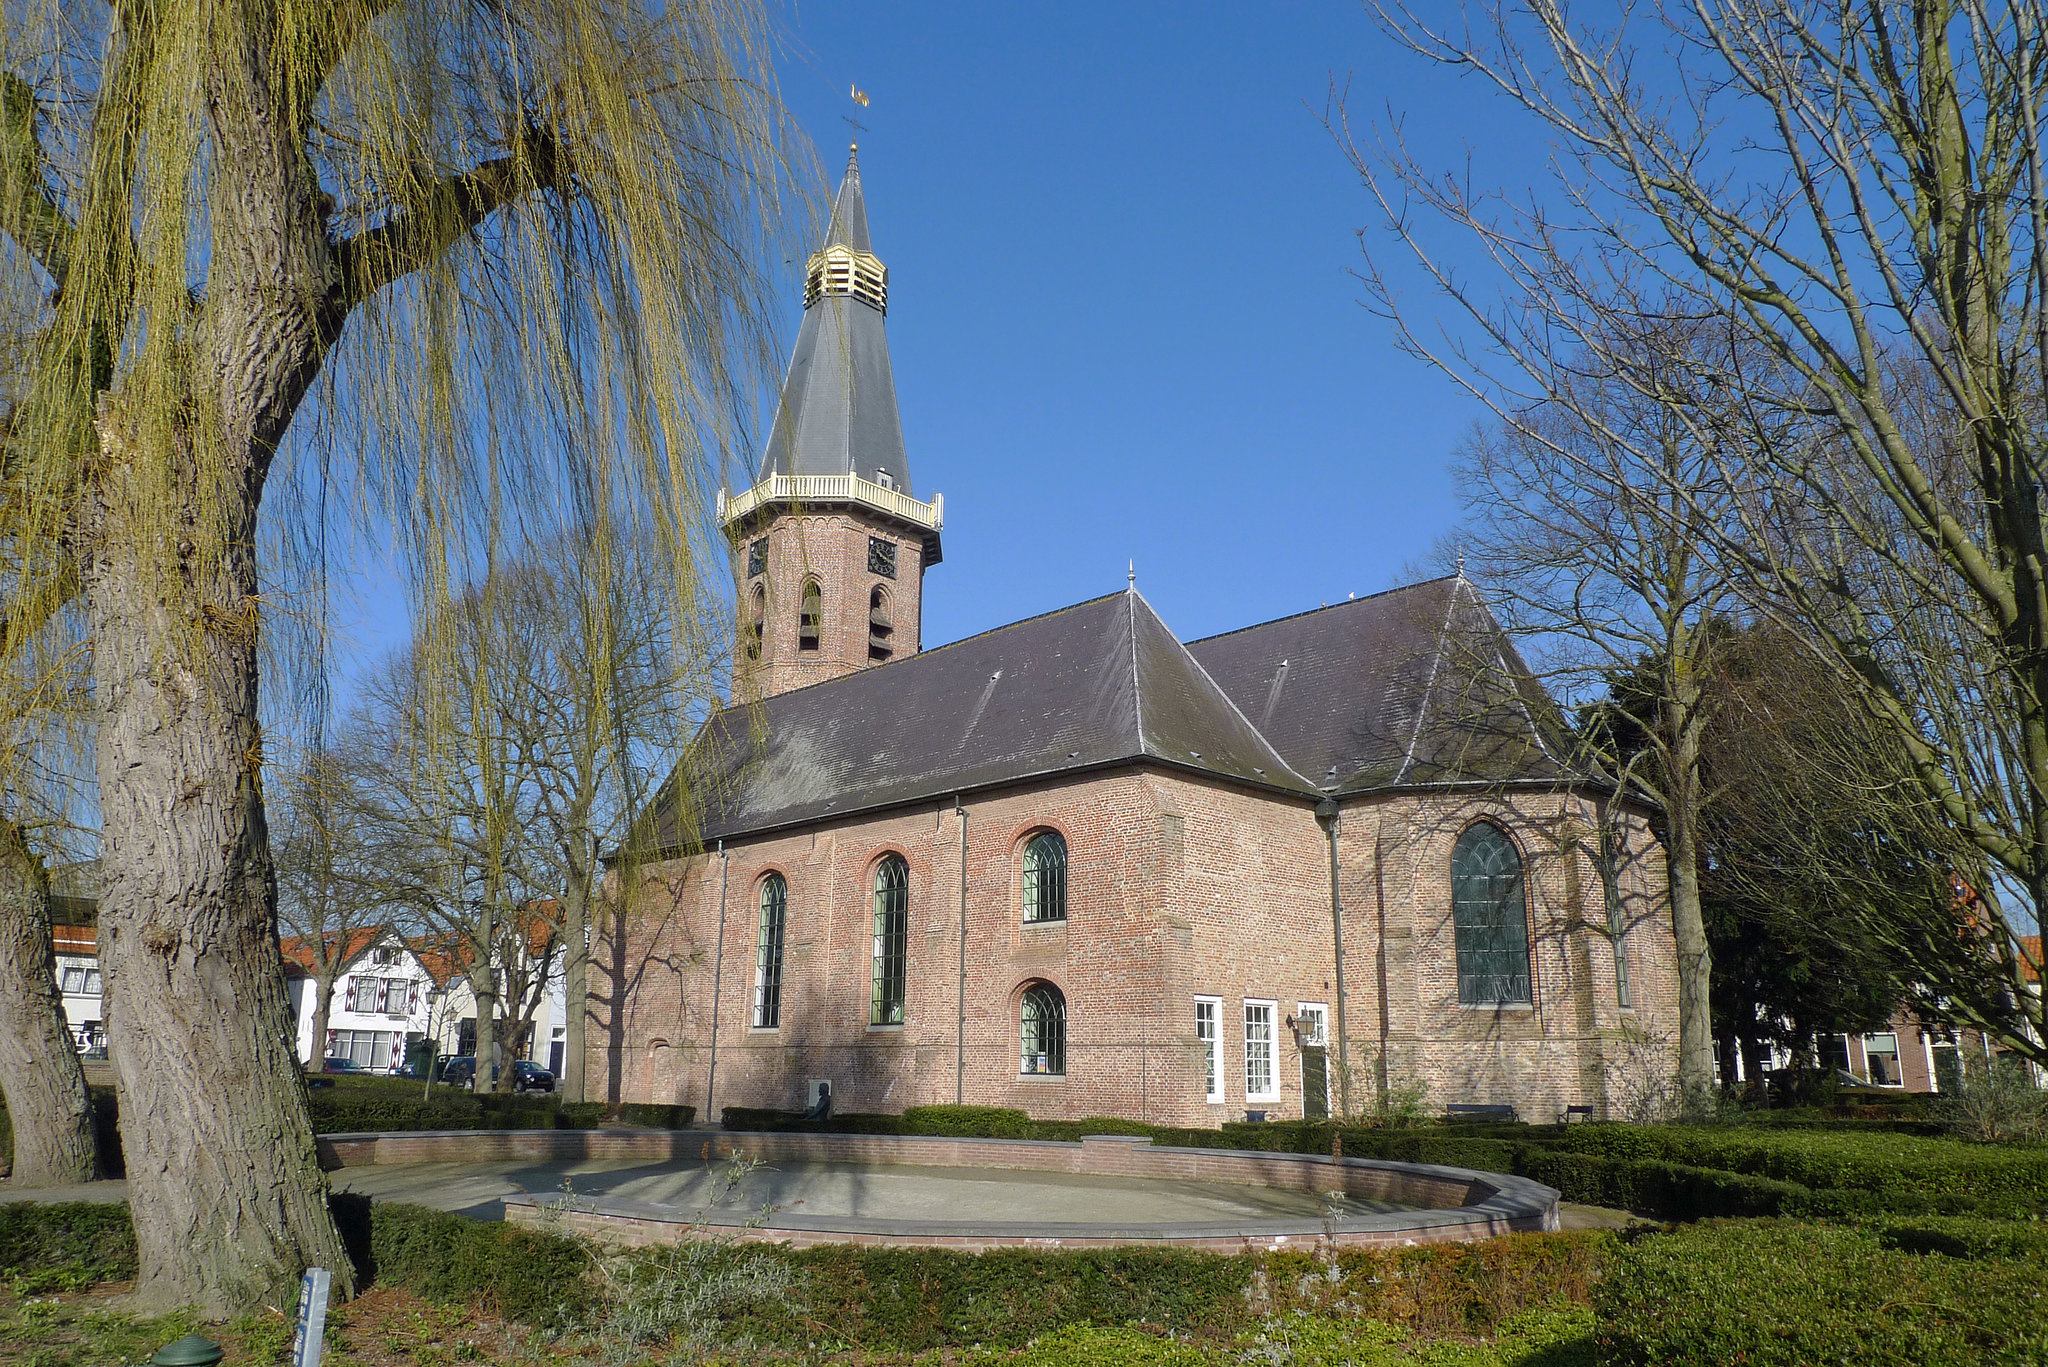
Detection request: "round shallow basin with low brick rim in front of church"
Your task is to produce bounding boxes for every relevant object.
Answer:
[322,1131,1556,1250]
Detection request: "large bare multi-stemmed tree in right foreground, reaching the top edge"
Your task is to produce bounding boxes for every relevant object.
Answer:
[1350,0,2048,1049]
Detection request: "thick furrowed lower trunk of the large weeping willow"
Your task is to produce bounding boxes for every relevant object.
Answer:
[84,438,354,1316]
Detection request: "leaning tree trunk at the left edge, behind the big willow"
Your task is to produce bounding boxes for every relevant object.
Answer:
[0,820,100,1187]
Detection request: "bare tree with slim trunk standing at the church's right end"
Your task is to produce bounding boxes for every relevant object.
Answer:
[1456,320,1735,1092]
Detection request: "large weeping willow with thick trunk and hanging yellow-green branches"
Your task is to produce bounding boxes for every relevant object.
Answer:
[0,0,788,1314]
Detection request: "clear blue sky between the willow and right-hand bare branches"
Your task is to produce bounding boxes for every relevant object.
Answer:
[753,0,1540,646]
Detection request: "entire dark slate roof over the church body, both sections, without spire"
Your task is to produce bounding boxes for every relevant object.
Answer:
[643,580,1563,851]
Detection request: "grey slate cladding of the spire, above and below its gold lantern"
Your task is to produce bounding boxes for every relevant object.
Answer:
[756,148,909,492]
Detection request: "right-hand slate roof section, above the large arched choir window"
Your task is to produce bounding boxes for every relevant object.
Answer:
[1188,576,1565,793]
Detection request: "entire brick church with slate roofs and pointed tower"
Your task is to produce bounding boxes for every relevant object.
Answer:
[588,160,1677,1125]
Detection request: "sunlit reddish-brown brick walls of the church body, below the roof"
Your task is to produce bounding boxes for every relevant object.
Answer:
[588,766,1677,1125]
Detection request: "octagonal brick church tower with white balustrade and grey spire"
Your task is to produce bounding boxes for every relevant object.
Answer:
[719,148,946,699]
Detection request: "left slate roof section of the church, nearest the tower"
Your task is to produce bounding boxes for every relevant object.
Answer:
[655,590,1315,848]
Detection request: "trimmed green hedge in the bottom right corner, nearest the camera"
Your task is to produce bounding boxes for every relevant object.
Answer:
[1593,1221,2048,1367]
